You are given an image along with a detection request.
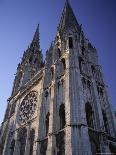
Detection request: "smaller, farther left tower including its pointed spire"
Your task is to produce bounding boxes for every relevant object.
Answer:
[12,25,43,95]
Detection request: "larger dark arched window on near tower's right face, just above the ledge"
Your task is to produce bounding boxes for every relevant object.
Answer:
[85,103,94,128]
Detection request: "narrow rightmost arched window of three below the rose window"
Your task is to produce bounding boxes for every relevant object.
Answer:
[29,129,35,155]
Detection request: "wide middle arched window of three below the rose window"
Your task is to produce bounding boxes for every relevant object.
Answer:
[18,127,27,155]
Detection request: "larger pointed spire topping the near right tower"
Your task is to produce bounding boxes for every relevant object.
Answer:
[58,0,79,31]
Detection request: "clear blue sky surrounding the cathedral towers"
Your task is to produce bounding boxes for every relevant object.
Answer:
[0,0,116,122]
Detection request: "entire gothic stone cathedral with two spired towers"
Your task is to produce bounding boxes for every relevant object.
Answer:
[0,0,116,155]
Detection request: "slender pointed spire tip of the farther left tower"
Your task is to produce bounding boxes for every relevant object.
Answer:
[32,24,40,49]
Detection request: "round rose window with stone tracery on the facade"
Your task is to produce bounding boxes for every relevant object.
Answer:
[19,91,37,123]
